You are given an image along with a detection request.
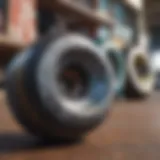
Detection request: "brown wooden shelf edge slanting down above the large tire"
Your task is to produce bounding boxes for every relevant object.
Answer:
[39,0,114,26]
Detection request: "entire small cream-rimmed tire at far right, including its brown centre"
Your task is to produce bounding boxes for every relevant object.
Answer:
[125,47,155,98]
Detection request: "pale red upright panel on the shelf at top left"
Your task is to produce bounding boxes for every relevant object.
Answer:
[9,0,36,43]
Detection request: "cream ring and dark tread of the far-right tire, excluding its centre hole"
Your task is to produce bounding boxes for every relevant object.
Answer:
[125,47,155,99]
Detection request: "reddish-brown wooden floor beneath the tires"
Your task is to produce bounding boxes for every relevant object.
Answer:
[0,91,160,160]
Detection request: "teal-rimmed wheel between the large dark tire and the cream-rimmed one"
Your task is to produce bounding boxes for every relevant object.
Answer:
[104,43,126,95]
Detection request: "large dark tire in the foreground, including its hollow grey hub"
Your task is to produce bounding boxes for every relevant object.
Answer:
[6,32,114,140]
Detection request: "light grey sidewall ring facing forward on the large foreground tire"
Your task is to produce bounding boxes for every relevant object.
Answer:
[35,34,114,126]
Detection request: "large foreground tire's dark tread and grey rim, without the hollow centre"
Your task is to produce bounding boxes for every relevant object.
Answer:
[6,31,114,140]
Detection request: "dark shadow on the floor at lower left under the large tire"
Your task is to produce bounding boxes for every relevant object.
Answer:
[0,133,80,153]
